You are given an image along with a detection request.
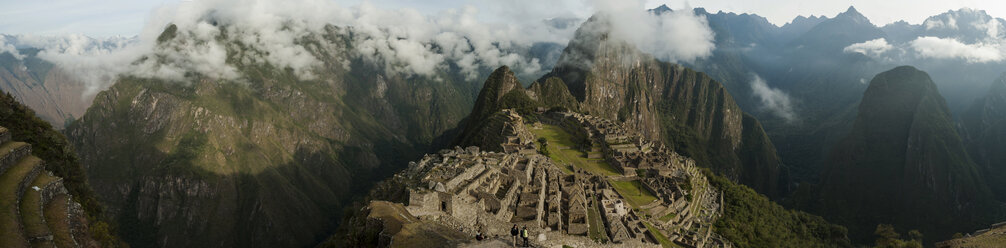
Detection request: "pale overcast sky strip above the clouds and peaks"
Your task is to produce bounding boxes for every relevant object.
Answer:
[0,0,1006,37]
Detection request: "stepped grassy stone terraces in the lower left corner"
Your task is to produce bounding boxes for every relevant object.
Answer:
[0,127,88,248]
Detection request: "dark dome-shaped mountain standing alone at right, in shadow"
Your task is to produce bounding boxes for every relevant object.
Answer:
[815,66,994,241]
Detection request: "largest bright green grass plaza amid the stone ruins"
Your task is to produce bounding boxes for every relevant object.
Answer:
[531,123,622,176]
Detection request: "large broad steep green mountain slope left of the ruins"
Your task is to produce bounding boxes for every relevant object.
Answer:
[66,26,475,247]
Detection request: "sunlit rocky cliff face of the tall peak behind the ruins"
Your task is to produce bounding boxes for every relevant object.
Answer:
[539,16,785,197]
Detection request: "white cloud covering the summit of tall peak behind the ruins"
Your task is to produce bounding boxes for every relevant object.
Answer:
[594,0,716,62]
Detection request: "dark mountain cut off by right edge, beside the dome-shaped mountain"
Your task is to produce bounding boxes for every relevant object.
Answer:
[962,73,1006,201]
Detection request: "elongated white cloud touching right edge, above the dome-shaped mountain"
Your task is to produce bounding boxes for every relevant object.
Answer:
[909,36,1003,63]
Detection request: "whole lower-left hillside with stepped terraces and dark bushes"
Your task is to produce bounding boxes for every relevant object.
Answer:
[0,91,128,247]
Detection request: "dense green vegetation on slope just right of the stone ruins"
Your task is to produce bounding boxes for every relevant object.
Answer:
[702,169,851,247]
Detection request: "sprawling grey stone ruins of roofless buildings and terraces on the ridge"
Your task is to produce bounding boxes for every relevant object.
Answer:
[380,111,730,247]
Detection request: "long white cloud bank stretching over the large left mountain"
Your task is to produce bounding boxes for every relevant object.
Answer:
[0,0,578,94]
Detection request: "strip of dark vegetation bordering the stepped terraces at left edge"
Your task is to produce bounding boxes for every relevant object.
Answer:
[0,92,128,247]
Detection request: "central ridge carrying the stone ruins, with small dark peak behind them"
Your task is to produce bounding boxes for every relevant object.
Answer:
[336,66,851,247]
